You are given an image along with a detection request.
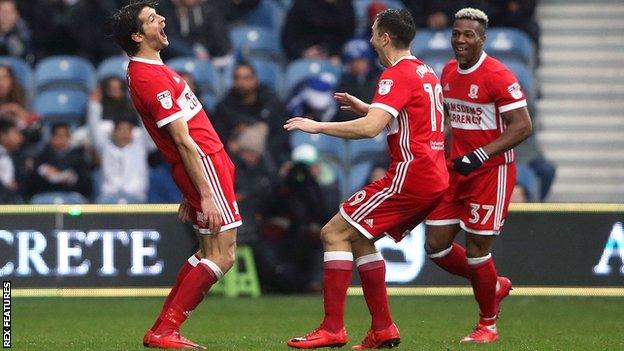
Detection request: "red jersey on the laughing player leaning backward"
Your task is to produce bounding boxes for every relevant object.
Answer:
[127,57,223,164]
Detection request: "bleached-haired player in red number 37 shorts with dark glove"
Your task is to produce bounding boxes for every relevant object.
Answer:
[426,8,531,343]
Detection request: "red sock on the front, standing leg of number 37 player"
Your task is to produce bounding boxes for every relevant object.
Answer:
[467,254,498,325]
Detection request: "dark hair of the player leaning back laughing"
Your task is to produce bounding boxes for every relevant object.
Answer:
[111,0,158,56]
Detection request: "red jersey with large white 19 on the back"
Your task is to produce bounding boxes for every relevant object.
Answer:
[370,56,449,196]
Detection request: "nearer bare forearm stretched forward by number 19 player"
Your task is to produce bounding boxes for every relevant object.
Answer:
[284,108,392,139]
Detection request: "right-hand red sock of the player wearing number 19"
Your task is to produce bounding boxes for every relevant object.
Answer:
[355,252,392,330]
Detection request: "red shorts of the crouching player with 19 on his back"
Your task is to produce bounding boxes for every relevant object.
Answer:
[340,177,444,242]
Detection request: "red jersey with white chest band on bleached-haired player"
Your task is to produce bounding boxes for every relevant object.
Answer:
[442,52,527,167]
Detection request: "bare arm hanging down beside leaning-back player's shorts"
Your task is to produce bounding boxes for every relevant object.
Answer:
[166,119,223,232]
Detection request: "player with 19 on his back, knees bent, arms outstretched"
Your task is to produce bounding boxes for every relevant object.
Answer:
[284,10,448,350]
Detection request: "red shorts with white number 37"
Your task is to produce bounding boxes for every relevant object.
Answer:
[425,163,516,235]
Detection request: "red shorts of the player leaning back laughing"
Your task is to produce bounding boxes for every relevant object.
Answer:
[171,149,242,234]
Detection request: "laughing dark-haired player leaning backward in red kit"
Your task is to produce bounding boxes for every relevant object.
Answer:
[112,1,241,349]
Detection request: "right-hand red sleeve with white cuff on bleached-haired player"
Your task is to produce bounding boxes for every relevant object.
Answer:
[489,69,527,113]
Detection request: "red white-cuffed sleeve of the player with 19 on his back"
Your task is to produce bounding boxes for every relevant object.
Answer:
[370,68,412,117]
